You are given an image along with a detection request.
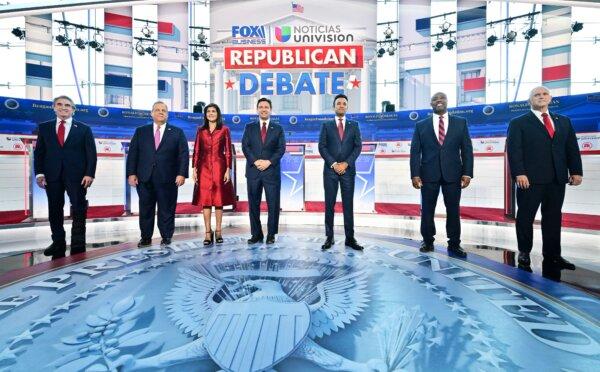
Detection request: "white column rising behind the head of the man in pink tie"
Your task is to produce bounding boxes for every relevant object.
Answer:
[131,5,160,110]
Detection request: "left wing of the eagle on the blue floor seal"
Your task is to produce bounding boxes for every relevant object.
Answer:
[165,267,225,337]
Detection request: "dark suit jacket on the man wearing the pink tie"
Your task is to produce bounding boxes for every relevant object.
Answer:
[127,123,190,183]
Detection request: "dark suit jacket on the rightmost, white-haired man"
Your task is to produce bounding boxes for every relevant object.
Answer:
[506,111,583,184]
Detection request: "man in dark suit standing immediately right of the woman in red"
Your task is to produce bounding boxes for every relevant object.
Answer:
[242,97,285,244]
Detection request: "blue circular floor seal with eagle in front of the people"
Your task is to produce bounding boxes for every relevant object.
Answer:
[0,233,600,371]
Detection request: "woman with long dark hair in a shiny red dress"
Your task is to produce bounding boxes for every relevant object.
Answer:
[192,103,235,245]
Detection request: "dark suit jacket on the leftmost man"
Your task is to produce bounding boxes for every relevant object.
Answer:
[33,119,97,182]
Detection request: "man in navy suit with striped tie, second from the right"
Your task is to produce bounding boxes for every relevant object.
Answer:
[410,92,473,257]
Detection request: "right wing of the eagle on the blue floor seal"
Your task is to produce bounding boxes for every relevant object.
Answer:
[308,271,369,338]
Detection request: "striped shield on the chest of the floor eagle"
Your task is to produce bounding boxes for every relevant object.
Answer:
[204,300,310,372]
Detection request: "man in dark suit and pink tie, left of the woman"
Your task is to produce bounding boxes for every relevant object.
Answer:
[127,101,189,247]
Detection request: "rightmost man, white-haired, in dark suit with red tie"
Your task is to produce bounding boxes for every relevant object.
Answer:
[506,87,583,281]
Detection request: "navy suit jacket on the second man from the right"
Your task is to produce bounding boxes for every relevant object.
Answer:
[410,115,473,182]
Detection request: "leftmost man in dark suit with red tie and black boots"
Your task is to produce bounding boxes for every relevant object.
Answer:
[33,96,97,259]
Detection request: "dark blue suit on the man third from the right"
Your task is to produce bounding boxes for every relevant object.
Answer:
[319,120,362,240]
